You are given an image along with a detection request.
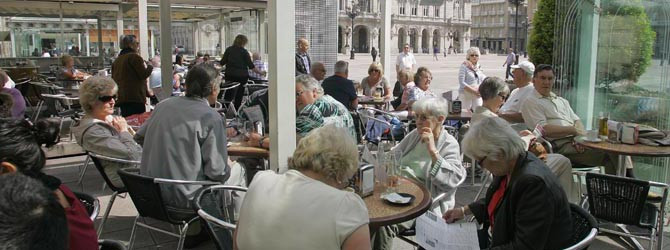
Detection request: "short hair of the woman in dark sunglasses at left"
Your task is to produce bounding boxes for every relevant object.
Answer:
[79,76,118,114]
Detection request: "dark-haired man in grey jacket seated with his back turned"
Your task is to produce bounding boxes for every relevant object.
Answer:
[135,63,230,221]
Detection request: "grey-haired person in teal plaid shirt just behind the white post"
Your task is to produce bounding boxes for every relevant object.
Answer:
[247,75,356,148]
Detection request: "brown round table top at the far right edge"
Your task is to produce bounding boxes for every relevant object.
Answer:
[575,136,670,157]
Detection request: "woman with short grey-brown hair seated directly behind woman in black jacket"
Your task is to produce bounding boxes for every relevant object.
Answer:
[472,76,579,202]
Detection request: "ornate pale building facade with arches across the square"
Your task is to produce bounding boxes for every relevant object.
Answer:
[338,0,472,54]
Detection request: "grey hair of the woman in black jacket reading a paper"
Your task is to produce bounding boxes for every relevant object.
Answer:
[461,117,526,161]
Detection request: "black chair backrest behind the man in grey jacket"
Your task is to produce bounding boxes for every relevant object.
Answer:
[118,168,179,223]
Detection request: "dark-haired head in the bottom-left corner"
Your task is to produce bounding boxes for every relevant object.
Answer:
[0,174,69,250]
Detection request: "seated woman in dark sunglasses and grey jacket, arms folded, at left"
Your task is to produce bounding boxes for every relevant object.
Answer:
[72,76,142,187]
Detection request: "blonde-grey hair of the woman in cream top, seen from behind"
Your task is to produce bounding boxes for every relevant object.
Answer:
[288,124,358,182]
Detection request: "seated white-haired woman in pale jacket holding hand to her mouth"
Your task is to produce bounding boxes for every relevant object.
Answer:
[374,97,466,249]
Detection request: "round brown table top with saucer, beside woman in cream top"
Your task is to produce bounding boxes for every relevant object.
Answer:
[363,177,431,228]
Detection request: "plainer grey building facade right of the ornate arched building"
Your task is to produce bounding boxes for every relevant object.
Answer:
[470,0,529,53]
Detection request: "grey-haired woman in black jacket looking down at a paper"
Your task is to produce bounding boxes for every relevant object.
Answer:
[443,117,572,249]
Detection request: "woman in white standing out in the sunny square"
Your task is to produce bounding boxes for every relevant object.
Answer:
[458,47,486,110]
